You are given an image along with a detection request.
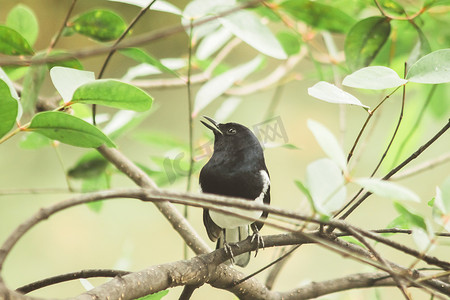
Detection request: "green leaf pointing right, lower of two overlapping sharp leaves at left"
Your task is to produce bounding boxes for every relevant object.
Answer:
[27,111,115,148]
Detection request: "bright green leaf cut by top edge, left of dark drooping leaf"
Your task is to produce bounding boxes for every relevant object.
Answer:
[280,0,355,33]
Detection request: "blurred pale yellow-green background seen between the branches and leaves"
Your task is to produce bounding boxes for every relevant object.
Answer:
[0,0,450,300]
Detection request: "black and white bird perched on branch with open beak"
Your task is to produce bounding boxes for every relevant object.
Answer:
[200,117,270,267]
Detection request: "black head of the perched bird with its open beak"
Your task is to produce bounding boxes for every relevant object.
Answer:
[200,116,262,152]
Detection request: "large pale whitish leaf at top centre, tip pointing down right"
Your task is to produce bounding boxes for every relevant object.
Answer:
[219,10,287,59]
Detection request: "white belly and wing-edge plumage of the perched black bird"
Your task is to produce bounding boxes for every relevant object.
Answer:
[209,170,270,228]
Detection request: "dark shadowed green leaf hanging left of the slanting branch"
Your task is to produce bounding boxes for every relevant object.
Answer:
[67,151,108,179]
